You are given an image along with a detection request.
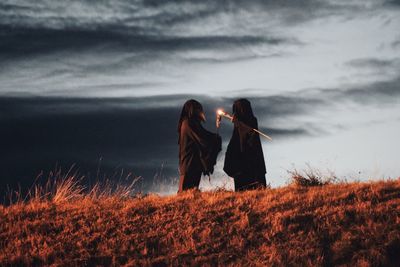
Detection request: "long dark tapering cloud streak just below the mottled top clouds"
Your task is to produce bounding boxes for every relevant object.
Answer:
[0,26,290,57]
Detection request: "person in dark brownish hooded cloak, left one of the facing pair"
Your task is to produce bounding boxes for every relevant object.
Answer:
[178,99,221,192]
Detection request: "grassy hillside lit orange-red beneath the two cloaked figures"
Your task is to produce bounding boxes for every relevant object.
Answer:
[0,179,400,266]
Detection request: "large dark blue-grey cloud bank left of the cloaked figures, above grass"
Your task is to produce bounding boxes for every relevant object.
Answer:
[0,98,179,197]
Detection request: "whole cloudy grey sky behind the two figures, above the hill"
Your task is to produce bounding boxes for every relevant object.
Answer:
[0,0,400,195]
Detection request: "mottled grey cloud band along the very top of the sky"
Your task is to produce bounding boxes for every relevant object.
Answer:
[0,0,350,29]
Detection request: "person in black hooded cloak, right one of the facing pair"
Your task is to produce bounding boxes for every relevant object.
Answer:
[224,99,266,191]
